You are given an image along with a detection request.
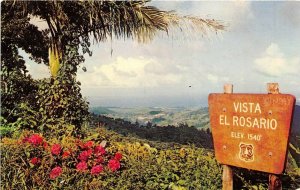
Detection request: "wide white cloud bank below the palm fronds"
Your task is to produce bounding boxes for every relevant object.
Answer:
[78,56,181,88]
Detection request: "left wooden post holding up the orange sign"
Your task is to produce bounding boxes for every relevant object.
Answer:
[222,84,233,190]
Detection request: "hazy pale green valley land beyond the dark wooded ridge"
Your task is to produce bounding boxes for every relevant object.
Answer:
[90,107,209,129]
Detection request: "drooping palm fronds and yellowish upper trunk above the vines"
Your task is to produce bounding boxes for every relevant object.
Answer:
[5,0,225,76]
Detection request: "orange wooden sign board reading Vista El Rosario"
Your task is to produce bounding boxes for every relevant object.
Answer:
[208,94,295,174]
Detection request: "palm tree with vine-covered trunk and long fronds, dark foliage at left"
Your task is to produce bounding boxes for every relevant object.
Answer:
[1,0,224,130]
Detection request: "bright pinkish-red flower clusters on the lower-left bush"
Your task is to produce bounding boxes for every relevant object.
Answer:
[21,134,122,179]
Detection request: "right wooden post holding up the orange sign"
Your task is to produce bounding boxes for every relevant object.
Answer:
[267,83,282,190]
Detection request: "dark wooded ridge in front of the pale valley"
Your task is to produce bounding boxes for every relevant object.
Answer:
[93,115,213,150]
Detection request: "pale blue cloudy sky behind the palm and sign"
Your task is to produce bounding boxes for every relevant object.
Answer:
[27,1,300,107]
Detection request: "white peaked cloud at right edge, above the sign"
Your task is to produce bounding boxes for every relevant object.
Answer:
[254,43,300,77]
